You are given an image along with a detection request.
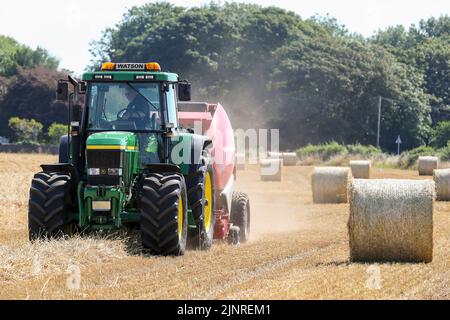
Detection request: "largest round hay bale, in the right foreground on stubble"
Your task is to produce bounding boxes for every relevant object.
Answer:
[348,179,434,262]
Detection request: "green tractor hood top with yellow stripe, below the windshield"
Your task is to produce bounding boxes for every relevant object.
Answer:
[86,131,138,150]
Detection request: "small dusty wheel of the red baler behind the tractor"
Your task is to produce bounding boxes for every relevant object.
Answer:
[231,192,250,243]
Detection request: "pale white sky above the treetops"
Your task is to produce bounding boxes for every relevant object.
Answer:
[0,0,450,74]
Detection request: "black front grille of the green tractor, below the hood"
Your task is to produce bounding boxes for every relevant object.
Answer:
[86,150,123,186]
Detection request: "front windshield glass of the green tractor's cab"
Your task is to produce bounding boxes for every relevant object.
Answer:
[88,82,162,131]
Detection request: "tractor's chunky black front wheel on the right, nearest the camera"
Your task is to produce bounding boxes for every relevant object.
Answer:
[140,173,188,256]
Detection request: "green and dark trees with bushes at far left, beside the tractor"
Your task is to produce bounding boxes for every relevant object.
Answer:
[0,35,68,144]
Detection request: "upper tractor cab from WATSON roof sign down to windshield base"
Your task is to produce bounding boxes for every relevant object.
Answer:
[83,63,185,131]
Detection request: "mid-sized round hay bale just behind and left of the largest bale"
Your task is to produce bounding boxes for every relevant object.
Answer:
[311,167,350,203]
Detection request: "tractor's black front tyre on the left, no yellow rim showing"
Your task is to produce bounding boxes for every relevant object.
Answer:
[28,172,72,240]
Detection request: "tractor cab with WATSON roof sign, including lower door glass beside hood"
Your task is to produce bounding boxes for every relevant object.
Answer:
[81,62,190,167]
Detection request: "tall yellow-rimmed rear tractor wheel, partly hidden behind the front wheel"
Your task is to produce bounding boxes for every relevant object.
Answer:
[188,155,215,250]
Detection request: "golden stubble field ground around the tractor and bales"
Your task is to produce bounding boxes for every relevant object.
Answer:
[0,154,450,299]
